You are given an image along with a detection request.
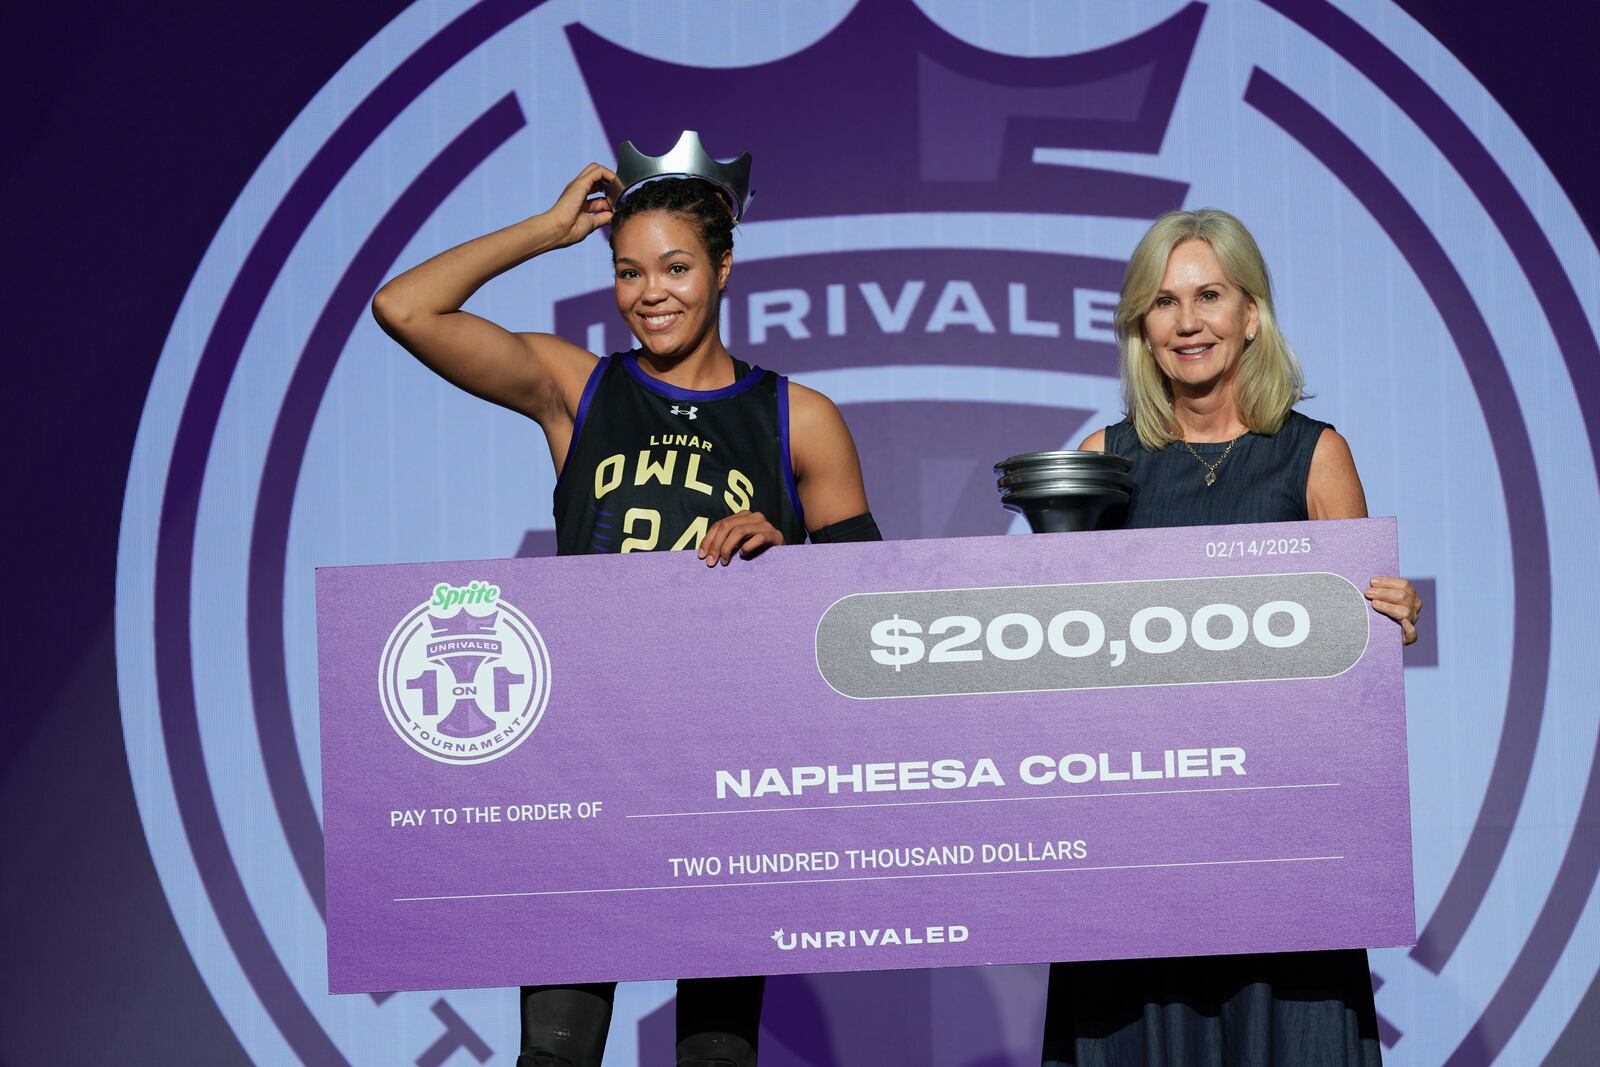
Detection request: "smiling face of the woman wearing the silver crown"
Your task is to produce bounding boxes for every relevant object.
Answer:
[611,211,733,357]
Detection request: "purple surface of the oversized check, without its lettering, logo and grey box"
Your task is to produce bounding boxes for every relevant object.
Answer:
[317,520,1416,992]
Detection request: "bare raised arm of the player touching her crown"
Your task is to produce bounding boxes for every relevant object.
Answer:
[373,163,616,466]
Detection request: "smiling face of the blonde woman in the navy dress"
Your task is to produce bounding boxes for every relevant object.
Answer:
[1144,240,1259,397]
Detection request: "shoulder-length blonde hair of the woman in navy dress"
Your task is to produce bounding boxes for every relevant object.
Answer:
[1115,208,1306,450]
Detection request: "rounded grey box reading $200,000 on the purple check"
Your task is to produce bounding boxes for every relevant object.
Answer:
[816,573,1368,699]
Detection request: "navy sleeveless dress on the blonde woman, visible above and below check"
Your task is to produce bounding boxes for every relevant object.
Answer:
[1043,411,1382,1067]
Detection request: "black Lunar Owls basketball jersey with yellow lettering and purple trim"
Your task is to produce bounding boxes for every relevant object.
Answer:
[555,352,805,555]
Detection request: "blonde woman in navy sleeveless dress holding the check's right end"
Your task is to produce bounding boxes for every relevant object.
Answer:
[1043,210,1422,1067]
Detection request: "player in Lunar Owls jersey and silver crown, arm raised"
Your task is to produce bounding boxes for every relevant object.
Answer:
[373,131,878,1067]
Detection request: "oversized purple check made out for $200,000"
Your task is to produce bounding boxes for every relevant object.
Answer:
[317,520,1414,992]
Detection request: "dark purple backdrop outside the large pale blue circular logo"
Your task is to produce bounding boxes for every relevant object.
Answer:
[0,0,1600,1065]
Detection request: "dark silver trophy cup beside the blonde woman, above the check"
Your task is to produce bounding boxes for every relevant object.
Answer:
[995,451,1133,533]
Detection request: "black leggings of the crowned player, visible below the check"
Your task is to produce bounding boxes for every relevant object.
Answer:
[517,977,766,1067]
